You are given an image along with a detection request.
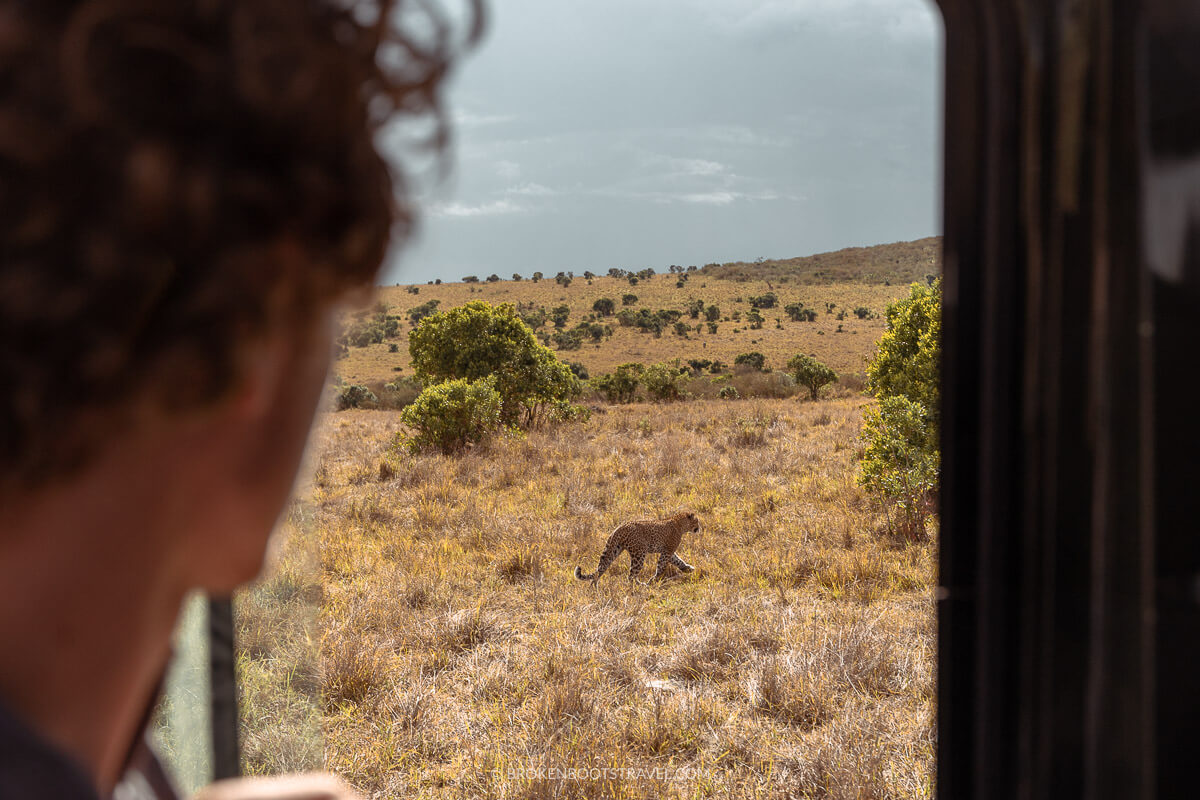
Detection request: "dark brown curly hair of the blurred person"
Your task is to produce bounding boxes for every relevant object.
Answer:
[0,0,482,493]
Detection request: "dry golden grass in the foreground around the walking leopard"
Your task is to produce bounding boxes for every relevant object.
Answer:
[239,398,934,798]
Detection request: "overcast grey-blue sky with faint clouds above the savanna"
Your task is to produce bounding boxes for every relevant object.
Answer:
[383,0,942,283]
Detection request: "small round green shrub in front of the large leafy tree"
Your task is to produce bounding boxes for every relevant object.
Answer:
[400,375,502,453]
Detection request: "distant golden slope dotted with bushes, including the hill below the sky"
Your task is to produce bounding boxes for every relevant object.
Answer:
[335,237,941,385]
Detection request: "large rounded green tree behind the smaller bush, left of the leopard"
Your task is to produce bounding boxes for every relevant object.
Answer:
[408,300,581,426]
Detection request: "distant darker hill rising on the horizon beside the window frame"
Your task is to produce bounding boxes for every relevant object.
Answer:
[700,236,942,285]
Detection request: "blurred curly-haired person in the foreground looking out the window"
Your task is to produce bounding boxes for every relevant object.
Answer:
[0,0,481,800]
